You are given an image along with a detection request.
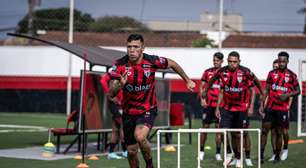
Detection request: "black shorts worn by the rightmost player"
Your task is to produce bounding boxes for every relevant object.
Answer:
[262,109,289,129]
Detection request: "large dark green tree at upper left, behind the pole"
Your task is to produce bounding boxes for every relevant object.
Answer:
[17,8,94,33]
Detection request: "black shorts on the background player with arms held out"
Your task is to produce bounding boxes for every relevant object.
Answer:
[220,109,250,128]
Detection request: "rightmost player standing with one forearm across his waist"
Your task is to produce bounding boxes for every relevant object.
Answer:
[260,51,300,162]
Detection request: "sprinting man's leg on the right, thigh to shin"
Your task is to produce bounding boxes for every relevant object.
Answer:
[135,109,157,168]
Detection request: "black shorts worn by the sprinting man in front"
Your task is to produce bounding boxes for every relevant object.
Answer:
[122,108,157,145]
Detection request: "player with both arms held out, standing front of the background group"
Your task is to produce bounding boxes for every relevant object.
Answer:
[203,51,263,167]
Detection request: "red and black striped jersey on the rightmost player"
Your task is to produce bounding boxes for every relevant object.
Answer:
[266,69,299,111]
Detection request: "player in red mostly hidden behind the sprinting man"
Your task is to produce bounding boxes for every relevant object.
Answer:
[100,73,127,159]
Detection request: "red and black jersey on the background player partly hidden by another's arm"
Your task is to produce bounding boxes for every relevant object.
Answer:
[201,67,220,107]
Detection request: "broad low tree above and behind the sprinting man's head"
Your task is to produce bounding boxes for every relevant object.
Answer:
[89,16,149,32]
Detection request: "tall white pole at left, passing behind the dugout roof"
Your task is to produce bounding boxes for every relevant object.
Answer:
[66,0,74,115]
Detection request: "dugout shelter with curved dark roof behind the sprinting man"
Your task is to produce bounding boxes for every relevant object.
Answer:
[8,33,177,152]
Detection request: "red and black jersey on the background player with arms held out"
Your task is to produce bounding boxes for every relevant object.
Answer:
[216,66,255,112]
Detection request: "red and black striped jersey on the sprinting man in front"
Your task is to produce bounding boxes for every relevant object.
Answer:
[111,53,168,115]
